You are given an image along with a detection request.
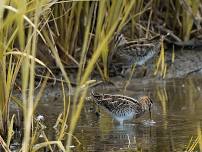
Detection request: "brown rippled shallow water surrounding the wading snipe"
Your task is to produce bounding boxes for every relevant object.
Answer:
[39,78,202,152]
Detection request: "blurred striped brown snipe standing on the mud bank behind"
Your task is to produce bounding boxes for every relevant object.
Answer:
[109,34,160,74]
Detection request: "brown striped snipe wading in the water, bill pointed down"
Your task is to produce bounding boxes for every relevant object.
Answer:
[91,91,152,124]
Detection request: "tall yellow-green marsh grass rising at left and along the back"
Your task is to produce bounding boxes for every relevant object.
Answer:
[0,0,201,152]
